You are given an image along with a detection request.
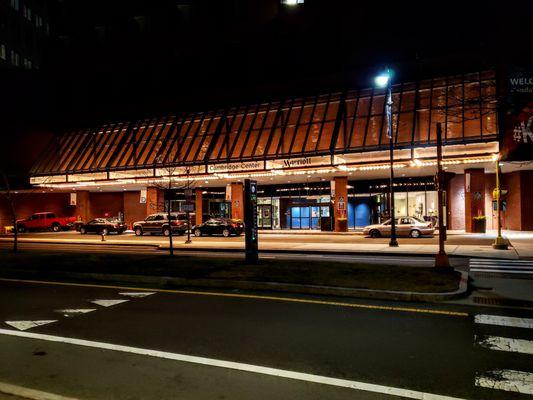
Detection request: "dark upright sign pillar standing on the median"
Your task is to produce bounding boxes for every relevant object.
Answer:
[244,179,259,264]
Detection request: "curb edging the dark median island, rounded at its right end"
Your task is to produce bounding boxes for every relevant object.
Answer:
[0,269,468,302]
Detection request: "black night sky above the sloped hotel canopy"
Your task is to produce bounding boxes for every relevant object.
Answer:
[0,0,533,175]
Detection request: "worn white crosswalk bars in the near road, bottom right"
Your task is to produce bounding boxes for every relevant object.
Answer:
[474,314,533,395]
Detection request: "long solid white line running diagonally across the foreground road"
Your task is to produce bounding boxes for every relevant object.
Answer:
[0,329,463,400]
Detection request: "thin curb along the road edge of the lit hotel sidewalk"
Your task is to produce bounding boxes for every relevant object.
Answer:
[0,238,511,260]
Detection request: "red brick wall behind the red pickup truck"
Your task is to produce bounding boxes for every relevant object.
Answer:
[0,193,75,232]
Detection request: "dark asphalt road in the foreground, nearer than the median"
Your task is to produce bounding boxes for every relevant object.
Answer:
[0,280,533,400]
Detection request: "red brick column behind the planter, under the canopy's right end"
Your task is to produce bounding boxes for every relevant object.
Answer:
[465,168,485,232]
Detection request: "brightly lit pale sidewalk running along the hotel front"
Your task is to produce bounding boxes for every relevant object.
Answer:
[0,236,520,259]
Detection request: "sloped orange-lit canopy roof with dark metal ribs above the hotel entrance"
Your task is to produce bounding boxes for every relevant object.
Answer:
[31,71,498,176]
